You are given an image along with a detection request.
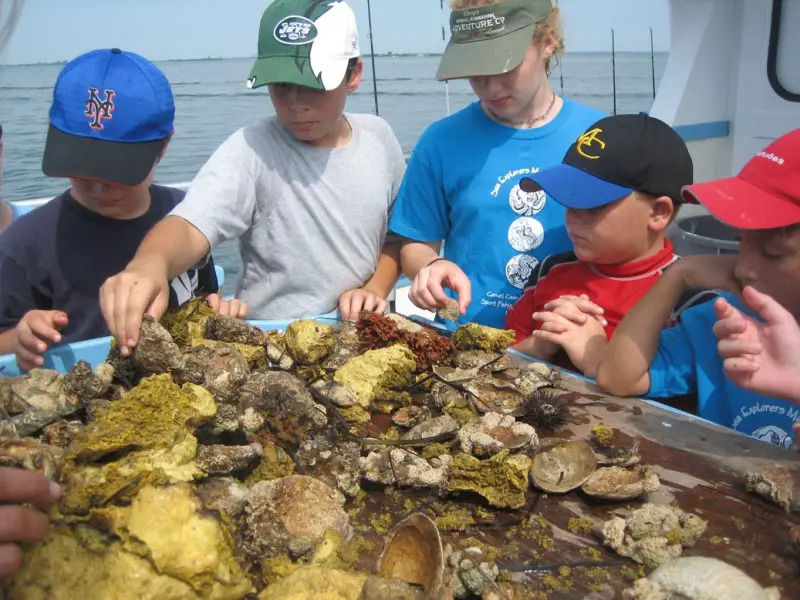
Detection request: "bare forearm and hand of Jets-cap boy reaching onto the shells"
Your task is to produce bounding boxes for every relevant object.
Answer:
[100,216,211,355]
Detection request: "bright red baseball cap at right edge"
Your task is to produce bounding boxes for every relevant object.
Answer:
[682,129,800,229]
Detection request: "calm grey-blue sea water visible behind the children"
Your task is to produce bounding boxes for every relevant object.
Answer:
[0,53,667,292]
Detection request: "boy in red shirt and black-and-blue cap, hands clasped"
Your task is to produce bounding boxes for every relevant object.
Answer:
[506,115,693,376]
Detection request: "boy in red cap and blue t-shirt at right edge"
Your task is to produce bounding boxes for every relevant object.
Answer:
[597,129,800,448]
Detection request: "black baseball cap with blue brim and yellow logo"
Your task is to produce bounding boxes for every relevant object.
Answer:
[520,114,694,209]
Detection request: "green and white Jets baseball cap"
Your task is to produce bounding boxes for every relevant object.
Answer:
[247,0,361,90]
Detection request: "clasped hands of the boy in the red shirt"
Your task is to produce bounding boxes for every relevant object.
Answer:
[533,294,608,377]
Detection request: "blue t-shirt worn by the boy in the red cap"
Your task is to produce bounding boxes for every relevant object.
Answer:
[647,294,800,448]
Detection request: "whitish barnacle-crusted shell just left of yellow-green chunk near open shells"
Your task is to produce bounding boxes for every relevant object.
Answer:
[359,448,450,488]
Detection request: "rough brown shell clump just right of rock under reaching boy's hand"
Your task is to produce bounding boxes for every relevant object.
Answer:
[173,344,250,404]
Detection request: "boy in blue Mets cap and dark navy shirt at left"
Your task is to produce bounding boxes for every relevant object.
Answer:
[0,49,218,369]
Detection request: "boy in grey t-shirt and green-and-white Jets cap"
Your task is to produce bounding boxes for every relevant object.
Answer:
[101,0,405,352]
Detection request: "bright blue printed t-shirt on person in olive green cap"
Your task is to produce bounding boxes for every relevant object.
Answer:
[389,99,605,327]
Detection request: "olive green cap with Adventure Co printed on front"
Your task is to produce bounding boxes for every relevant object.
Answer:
[436,0,553,81]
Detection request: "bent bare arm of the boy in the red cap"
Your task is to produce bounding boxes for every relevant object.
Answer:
[595,255,739,396]
